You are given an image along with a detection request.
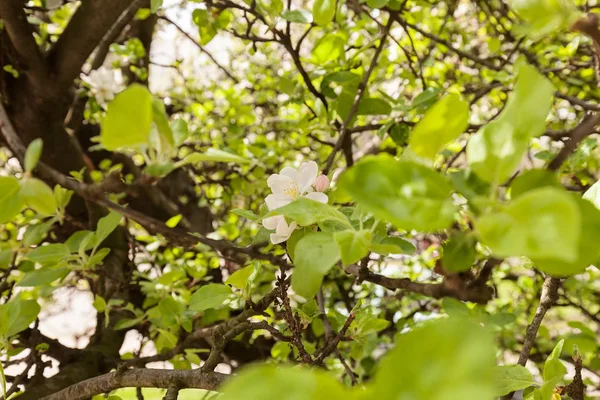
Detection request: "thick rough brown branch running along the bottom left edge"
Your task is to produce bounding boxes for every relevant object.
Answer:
[40,369,227,400]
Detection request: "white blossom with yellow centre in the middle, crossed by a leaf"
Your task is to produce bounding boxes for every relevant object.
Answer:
[262,161,329,244]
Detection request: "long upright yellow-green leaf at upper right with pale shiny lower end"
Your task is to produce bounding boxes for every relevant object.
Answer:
[467,62,554,184]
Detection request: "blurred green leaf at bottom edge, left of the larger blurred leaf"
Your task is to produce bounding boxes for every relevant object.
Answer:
[219,365,355,400]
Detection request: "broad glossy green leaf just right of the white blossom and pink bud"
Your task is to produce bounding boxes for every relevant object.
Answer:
[339,155,456,231]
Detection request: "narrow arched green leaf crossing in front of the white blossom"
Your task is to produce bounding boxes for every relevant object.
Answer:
[263,197,352,229]
